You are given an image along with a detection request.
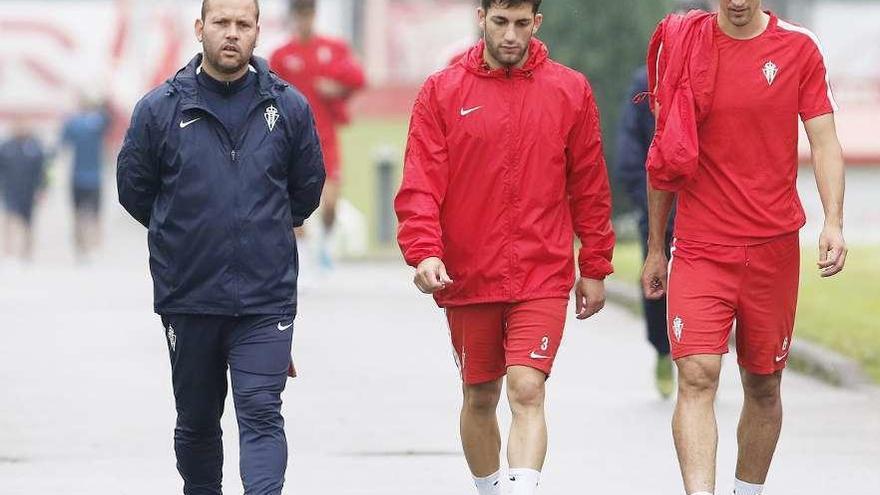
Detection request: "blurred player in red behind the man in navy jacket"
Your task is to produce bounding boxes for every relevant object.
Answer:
[269,0,365,266]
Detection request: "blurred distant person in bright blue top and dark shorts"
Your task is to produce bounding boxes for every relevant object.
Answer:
[61,94,110,262]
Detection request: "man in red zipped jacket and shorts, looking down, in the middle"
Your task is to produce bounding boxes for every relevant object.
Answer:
[395,0,614,495]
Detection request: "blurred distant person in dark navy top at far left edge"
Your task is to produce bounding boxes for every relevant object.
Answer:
[0,119,46,262]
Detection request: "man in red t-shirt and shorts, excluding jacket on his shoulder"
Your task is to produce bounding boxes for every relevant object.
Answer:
[642,0,847,495]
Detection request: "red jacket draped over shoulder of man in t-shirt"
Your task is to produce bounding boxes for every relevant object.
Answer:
[646,10,718,191]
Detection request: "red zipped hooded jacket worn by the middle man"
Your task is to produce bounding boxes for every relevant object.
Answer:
[395,39,614,307]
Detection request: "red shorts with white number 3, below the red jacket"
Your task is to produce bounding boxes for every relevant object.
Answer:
[446,298,568,385]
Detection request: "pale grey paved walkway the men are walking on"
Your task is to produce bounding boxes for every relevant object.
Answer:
[0,173,880,495]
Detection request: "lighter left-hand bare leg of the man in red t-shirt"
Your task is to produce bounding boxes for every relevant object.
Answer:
[672,355,721,494]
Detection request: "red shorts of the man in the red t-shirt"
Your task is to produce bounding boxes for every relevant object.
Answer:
[666,232,800,375]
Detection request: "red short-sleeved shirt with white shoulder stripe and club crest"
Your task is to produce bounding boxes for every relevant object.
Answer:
[676,14,837,246]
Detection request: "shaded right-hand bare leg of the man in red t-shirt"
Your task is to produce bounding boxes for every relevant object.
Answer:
[736,369,782,485]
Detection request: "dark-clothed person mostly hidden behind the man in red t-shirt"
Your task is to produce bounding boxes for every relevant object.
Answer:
[616,0,712,399]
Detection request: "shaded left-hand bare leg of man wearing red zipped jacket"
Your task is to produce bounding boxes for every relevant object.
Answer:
[460,378,502,478]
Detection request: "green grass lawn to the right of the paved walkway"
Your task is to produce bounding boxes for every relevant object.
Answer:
[613,242,880,383]
